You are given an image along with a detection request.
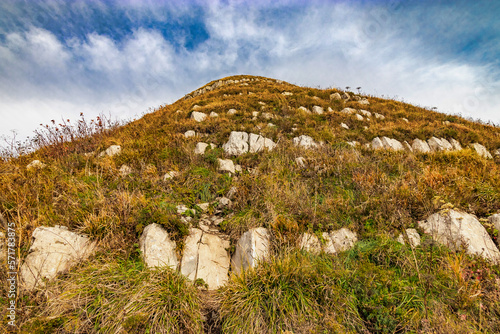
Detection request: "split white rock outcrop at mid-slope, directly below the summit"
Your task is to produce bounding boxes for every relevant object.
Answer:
[222,131,276,155]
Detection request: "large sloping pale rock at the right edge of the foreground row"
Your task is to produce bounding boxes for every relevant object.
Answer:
[418,210,500,263]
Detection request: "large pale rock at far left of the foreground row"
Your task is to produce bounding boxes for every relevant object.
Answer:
[20,226,95,290]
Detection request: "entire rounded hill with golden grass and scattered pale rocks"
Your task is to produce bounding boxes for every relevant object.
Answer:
[0,76,500,333]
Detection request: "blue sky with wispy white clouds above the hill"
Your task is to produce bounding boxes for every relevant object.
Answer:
[0,0,500,138]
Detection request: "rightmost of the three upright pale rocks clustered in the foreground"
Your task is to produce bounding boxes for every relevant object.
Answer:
[231,227,270,274]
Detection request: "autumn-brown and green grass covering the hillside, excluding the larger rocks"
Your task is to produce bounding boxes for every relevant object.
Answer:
[0,76,500,333]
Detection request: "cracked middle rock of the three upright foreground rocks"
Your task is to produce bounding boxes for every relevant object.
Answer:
[181,228,230,290]
